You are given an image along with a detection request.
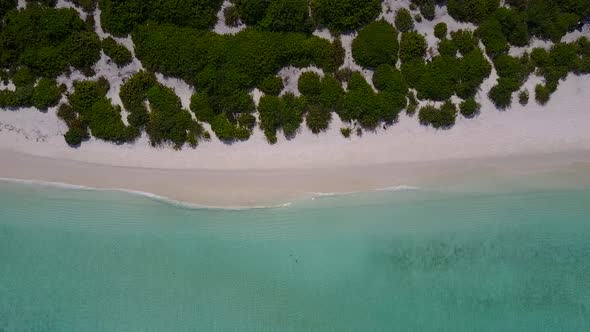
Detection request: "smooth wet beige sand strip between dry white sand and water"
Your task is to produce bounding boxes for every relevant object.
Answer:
[0,150,590,207]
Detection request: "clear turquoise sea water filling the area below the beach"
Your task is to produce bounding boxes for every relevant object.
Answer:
[0,183,590,331]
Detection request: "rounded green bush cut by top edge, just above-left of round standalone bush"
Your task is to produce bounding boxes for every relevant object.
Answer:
[311,0,381,32]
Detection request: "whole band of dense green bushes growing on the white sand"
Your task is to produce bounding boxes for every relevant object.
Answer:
[0,0,590,149]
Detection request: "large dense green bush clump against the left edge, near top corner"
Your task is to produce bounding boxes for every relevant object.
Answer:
[0,6,100,77]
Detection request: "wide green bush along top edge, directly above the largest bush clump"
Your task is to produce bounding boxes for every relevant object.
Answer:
[99,0,223,37]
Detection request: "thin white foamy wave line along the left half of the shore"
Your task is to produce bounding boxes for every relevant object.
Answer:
[0,177,293,211]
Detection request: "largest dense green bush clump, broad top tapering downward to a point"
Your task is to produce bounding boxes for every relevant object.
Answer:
[133,25,344,122]
